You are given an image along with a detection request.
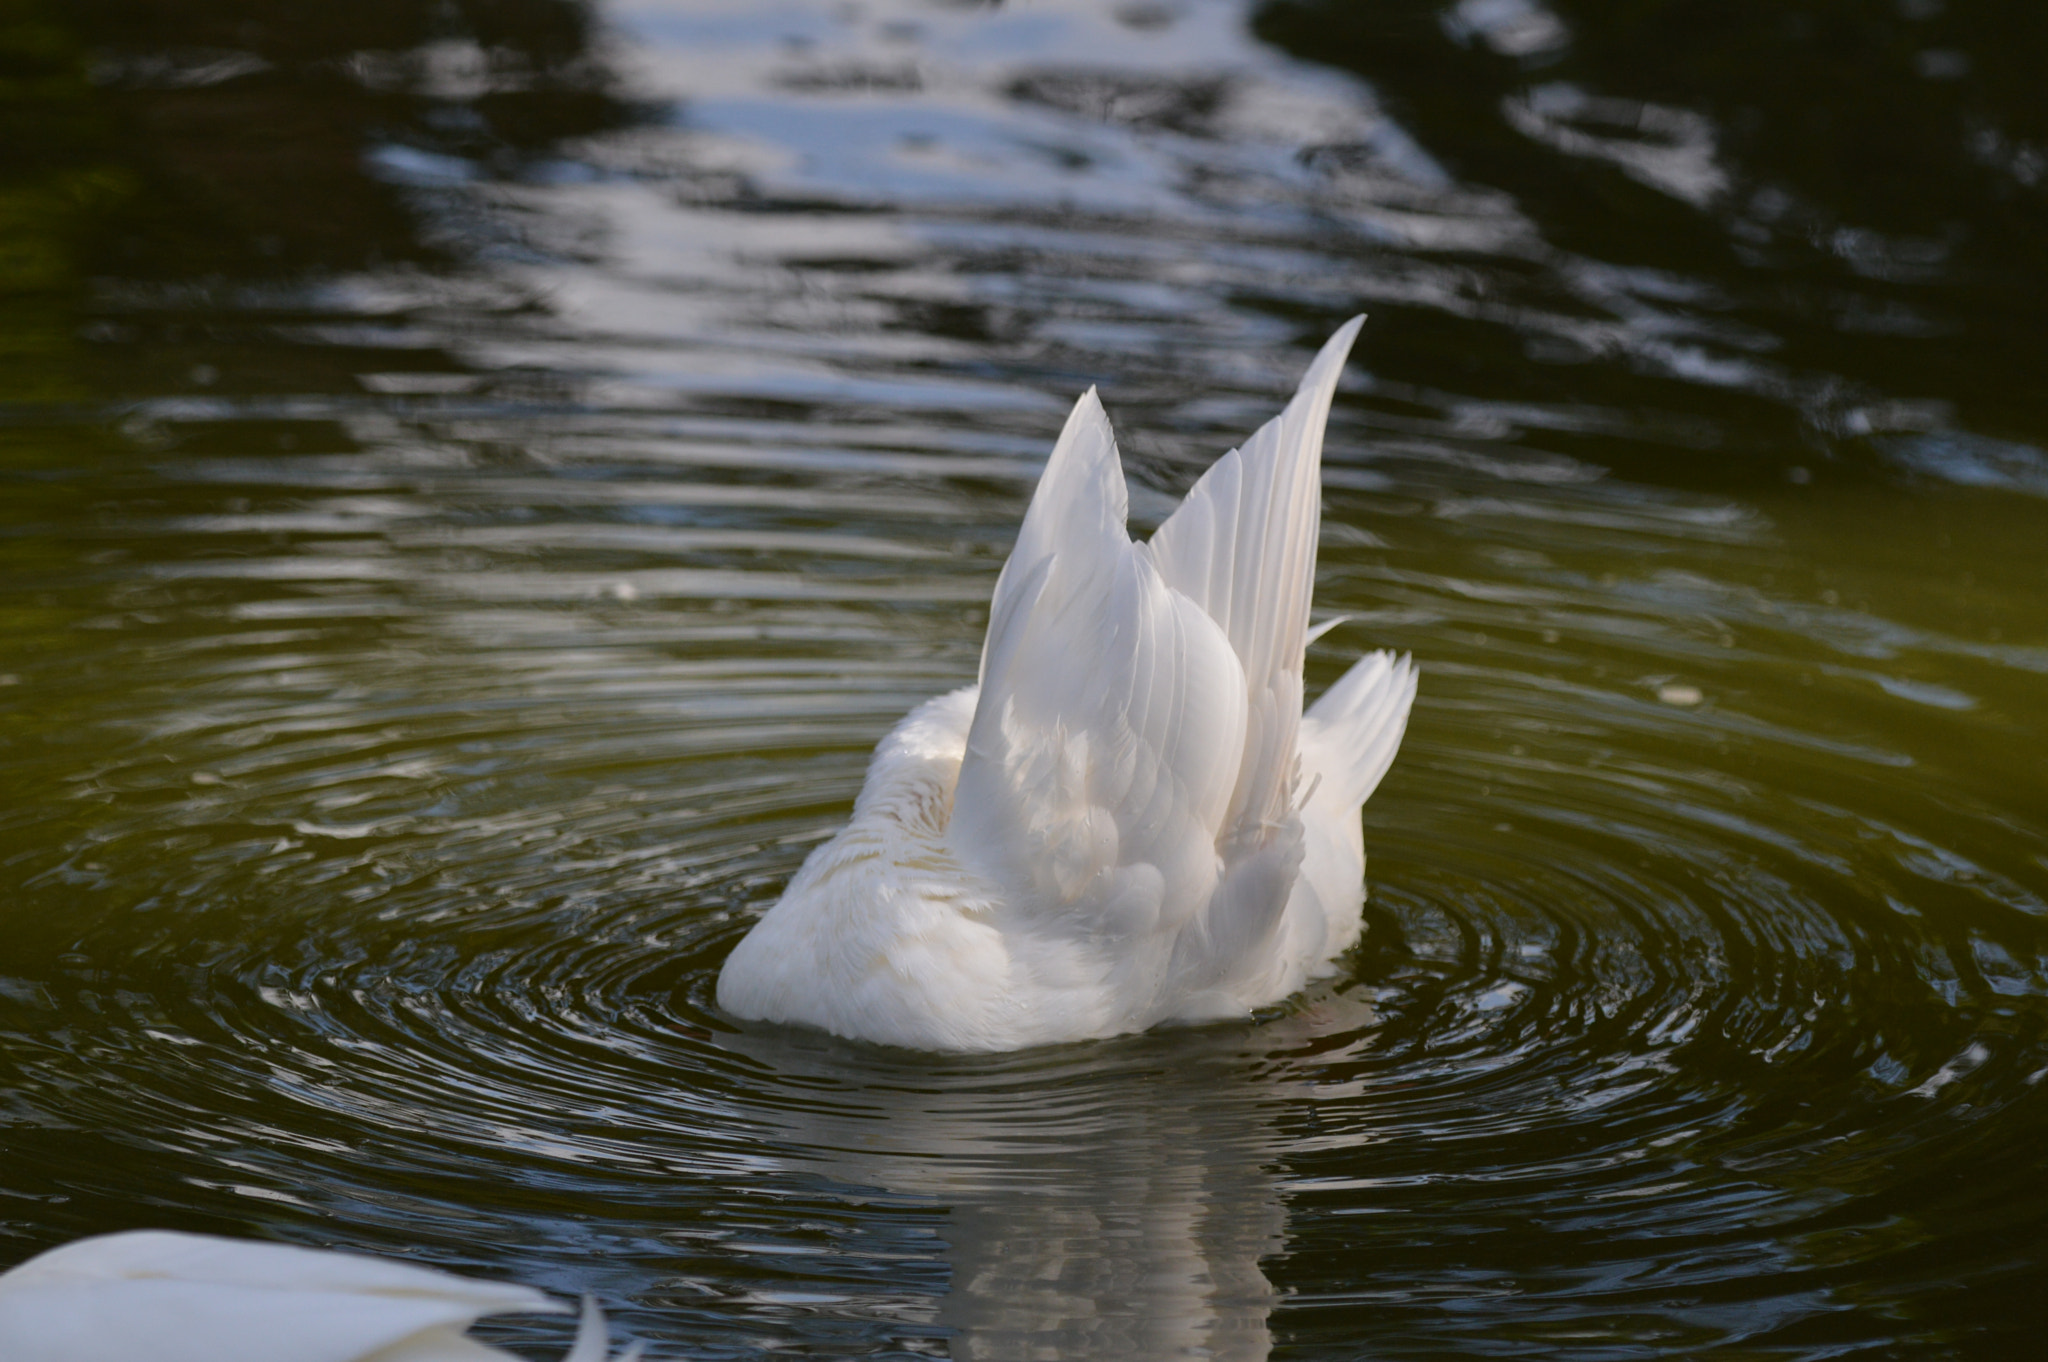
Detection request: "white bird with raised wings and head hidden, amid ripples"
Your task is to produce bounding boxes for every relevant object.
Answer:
[719,317,1415,1051]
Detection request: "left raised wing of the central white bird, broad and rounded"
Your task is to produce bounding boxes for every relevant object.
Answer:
[948,389,1245,979]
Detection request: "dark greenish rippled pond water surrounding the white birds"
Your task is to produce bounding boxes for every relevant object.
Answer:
[0,0,2048,1358]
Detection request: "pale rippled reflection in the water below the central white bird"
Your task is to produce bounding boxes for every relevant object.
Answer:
[721,993,1372,1362]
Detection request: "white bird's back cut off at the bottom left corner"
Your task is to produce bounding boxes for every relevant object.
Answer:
[0,1229,639,1362]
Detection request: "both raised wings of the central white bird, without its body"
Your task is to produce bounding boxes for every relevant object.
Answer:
[950,320,1362,1007]
